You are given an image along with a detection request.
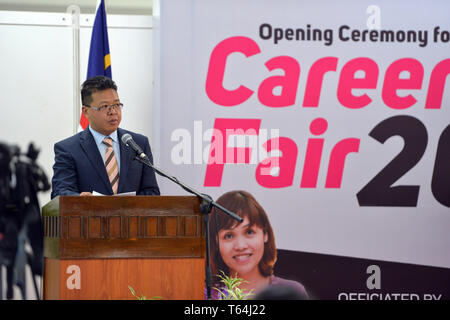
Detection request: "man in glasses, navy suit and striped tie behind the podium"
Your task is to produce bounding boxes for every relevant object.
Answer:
[51,76,160,198]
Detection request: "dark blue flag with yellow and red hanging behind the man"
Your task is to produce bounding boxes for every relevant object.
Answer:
[80,0,112,130]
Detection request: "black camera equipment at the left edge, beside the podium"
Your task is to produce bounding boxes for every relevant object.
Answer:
[0,142,50,300]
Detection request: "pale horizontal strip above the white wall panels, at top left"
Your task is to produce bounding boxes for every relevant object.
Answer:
[0,0,153,15]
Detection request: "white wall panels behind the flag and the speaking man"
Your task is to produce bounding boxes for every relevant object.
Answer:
[0,11,152,298]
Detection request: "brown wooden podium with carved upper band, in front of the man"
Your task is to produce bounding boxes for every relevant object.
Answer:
[42,196,206,300]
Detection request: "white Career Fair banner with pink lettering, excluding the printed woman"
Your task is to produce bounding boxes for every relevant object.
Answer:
[154,0,450,299]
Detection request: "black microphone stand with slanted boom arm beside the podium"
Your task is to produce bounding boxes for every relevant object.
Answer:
[134,155,243,300]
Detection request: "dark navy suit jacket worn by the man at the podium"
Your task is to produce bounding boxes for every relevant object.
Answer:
[51,128,160,199]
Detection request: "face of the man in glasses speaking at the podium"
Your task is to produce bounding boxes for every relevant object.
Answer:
[82,89,122,136]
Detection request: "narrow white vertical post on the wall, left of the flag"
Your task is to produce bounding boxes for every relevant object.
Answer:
[66,5,81,134]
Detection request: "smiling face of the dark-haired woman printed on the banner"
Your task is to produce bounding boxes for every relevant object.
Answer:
[219,217,268,276]
